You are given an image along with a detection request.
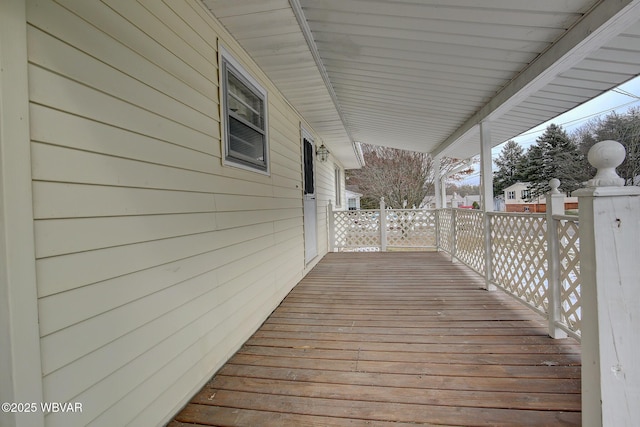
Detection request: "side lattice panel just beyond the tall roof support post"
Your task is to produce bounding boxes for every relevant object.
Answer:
[453,209,485,275]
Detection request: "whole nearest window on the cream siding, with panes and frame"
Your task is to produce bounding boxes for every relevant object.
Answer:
[220,48,269,173]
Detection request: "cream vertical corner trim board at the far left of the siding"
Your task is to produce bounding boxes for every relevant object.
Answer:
[0,0,45,427]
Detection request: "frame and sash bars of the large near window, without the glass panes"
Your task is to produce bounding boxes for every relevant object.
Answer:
[219,46,271,175]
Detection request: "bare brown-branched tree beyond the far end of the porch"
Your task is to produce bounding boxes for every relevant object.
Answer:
[347,144,464,209]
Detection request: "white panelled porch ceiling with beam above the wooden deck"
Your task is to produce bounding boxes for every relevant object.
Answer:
[203,0,640,167]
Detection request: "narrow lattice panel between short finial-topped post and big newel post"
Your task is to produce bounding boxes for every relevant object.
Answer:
[557,220,582,334]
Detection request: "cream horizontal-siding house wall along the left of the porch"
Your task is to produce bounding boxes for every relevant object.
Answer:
[2,0,344,426]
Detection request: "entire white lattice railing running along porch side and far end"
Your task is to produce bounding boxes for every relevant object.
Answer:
[330,202,581,339]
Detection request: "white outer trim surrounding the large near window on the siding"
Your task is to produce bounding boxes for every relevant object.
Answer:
[218,45,271,176]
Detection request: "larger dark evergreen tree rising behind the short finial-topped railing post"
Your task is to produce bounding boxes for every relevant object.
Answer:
[525,124,586,199]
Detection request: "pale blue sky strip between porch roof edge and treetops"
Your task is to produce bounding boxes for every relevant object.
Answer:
[458,76,640,185]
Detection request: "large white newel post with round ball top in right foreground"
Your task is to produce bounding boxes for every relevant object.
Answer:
[574,141,640,427]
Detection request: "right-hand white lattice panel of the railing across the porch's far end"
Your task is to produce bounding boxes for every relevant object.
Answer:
[387,209,436,248]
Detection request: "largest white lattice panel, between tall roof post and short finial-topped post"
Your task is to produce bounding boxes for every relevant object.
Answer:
[491,214,549,313]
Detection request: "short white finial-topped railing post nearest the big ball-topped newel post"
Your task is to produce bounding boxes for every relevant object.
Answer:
[547,178,567,339]
